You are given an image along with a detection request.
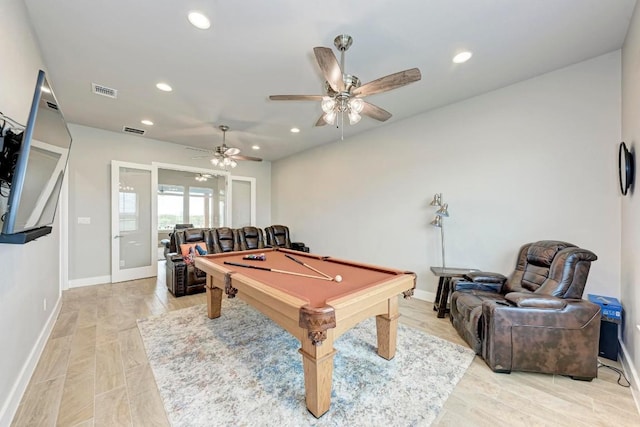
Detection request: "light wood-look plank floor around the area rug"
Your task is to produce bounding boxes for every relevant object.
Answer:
[12,263,640,427]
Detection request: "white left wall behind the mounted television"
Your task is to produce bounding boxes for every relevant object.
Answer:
[0,0,60,425]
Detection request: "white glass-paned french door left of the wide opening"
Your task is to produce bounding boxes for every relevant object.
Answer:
[111,160,158,283]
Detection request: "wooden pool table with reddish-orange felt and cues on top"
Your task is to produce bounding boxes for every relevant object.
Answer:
[194,248,416,417]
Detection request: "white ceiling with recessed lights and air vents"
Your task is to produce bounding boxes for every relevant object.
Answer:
[25,0,636,160]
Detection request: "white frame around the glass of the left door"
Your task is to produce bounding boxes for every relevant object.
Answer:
[111,160,158,283]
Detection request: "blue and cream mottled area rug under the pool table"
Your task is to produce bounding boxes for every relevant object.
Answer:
[138,299,474,427]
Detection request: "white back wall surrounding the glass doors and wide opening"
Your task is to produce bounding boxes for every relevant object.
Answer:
[63,124,271,286]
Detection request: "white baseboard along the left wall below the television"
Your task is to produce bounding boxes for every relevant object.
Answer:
[0,297,62,426]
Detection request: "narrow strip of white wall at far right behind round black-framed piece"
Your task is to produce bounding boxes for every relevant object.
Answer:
[620,0,640,406]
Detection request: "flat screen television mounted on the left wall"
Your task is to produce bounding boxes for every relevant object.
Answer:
[0,70,71,243]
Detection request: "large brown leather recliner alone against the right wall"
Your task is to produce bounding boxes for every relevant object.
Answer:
[450,240,600,380]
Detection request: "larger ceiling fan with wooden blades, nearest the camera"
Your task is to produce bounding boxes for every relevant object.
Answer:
[269,34,421,126]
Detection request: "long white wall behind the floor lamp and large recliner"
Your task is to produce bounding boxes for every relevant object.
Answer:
[272,51,620,298]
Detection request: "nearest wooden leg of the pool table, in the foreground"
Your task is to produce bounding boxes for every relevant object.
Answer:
[300,329,336,418]
